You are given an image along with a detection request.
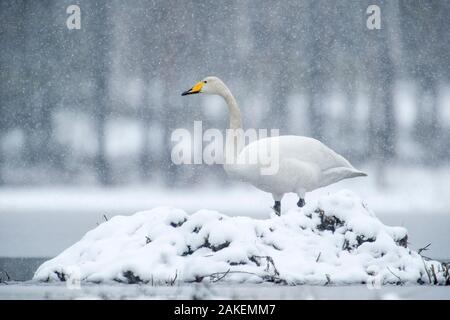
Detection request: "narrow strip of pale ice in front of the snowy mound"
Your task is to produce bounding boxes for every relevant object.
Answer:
[0,282,450,300]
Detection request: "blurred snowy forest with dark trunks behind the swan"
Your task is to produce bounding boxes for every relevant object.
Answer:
[0,0,450,186]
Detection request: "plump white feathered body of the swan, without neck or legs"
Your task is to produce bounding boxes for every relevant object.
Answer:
[229,136,365,195]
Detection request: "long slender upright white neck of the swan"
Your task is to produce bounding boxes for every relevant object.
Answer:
[222,87,244,164]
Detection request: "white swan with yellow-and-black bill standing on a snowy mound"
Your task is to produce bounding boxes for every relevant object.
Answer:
[181,76,367,215]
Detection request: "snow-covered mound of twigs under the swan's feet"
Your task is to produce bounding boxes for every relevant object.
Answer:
[34,190,449,285]
